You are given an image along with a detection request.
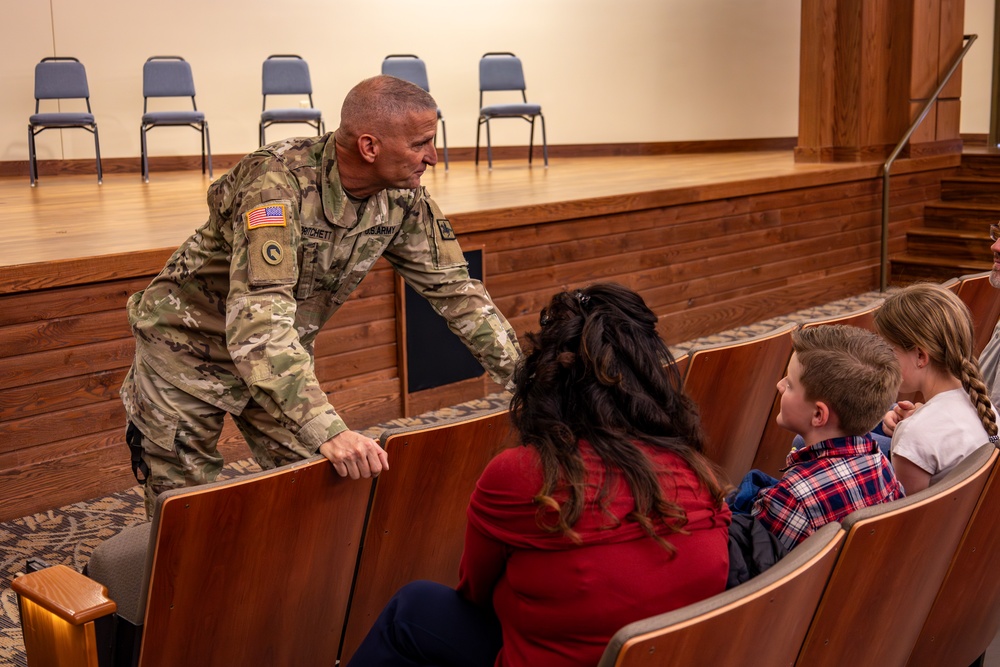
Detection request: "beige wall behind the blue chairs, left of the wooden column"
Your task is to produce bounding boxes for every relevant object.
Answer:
[0,0,800,160]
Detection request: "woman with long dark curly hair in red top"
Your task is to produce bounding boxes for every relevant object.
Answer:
[351,284,731,667]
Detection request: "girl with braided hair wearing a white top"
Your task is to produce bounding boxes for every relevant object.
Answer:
[875,283,997,494]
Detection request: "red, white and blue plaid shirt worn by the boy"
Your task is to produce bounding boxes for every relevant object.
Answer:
[751,436,903,549]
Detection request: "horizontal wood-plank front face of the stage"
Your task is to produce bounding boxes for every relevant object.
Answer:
[0,158,952,520]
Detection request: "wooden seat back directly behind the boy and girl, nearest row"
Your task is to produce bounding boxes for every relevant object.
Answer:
[796,444,997,667]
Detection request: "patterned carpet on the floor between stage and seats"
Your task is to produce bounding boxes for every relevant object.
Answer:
[0,292,884,667]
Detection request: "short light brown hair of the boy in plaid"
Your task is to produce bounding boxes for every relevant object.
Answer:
[792,324,903,435]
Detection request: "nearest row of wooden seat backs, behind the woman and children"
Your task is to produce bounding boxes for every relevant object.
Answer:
[599,444,1000,667]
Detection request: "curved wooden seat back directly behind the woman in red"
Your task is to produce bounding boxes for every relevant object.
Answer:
[598,522,845,667]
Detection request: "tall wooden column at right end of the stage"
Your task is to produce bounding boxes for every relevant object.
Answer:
[795,0,965,162]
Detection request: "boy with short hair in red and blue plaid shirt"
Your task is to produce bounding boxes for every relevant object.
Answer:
[751,325,903,549]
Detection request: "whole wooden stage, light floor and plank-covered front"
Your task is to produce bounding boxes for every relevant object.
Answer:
[0,151,960,520]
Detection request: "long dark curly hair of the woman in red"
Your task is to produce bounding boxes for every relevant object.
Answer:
[511,283,724,551]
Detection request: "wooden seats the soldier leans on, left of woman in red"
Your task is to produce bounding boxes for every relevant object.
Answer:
[12,410,510,667]
